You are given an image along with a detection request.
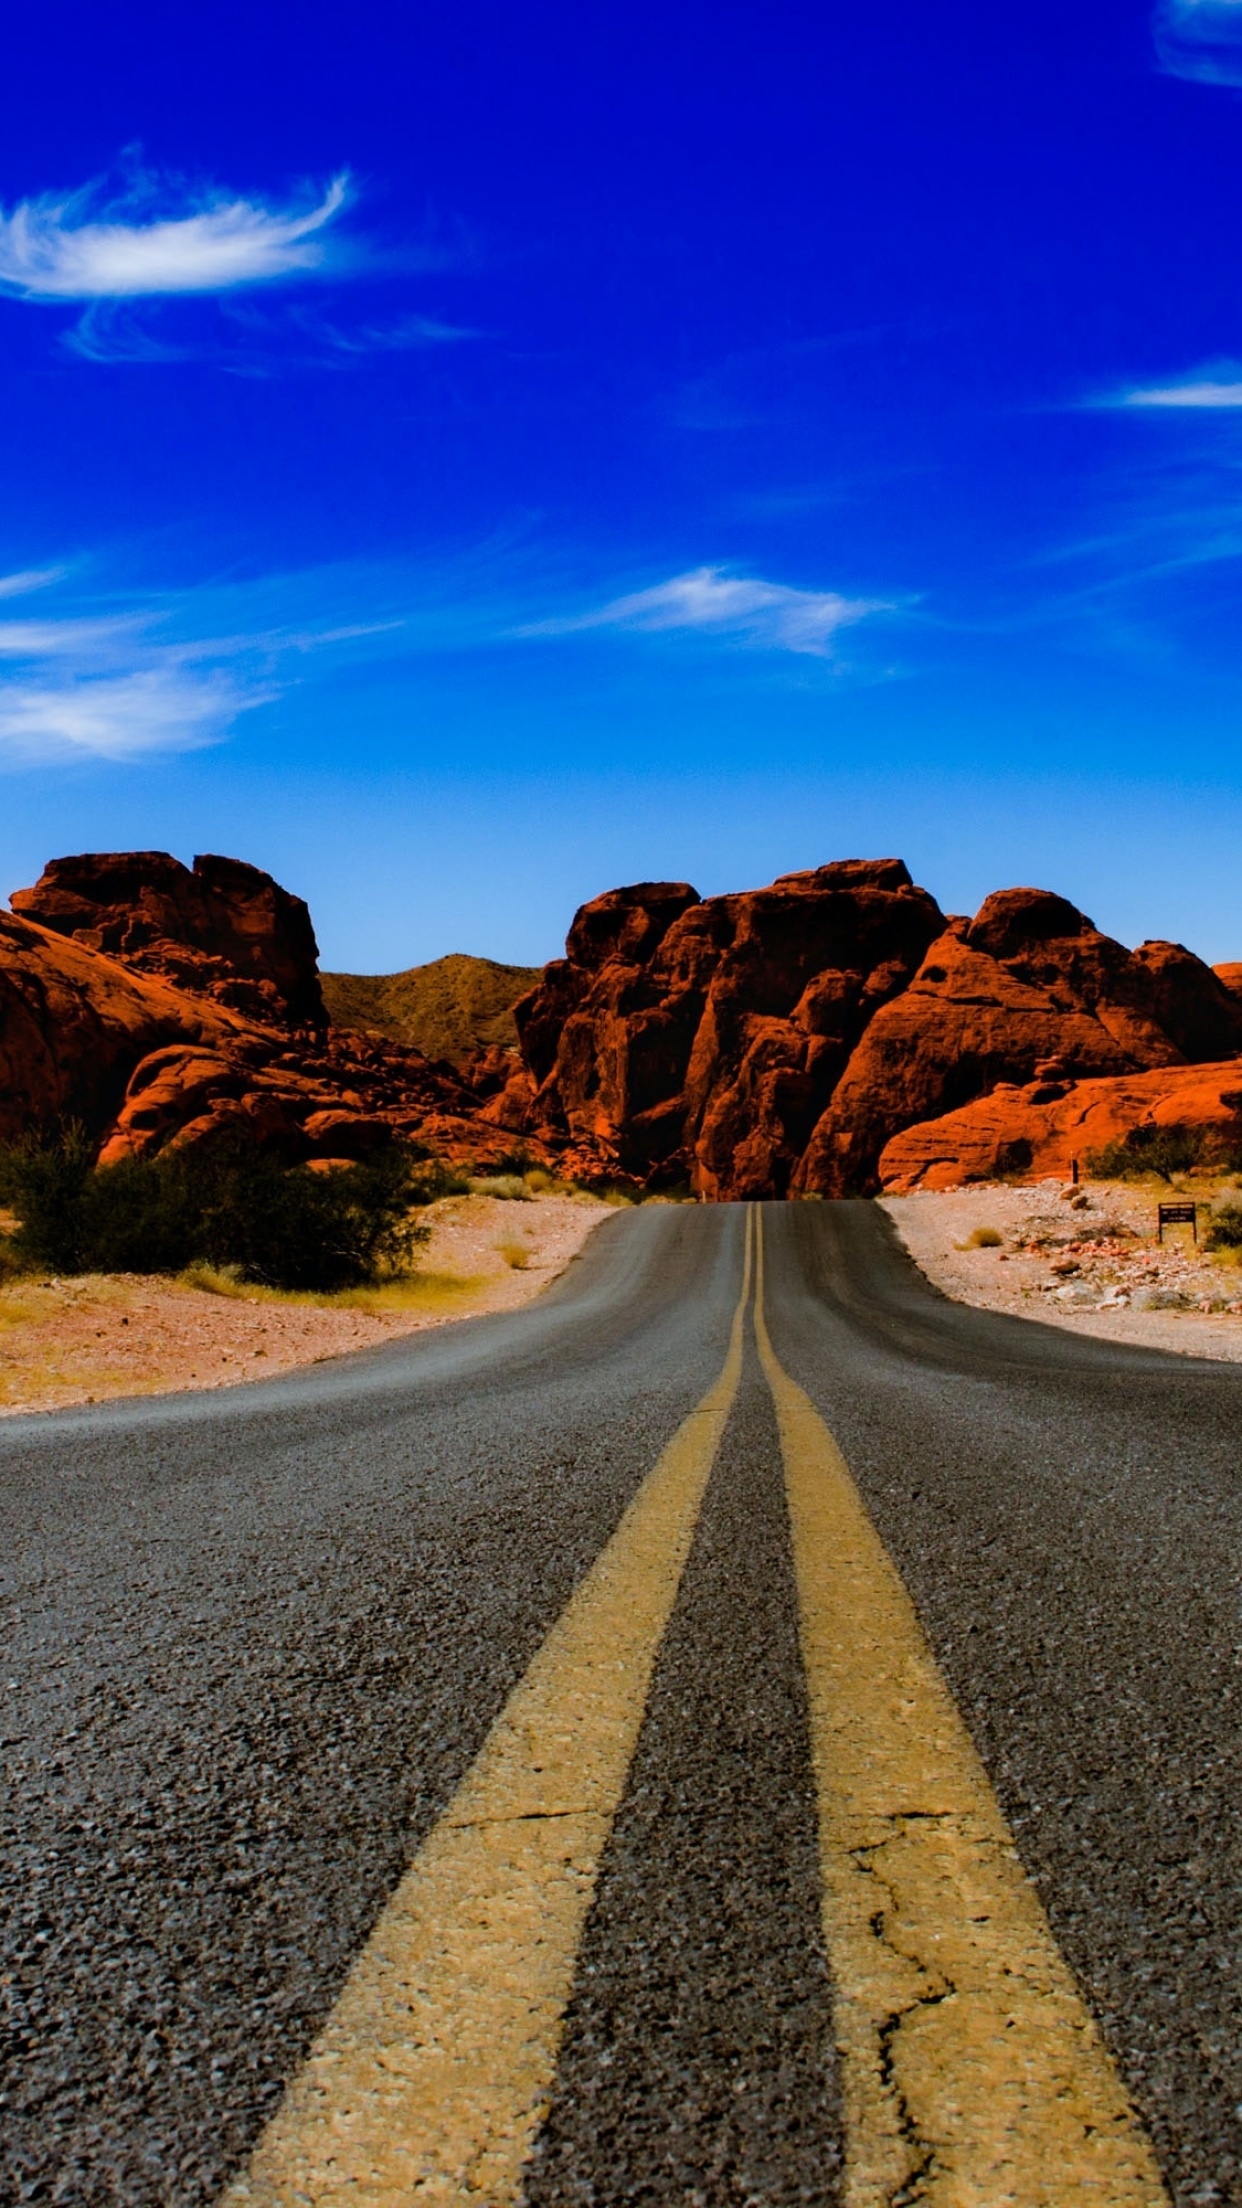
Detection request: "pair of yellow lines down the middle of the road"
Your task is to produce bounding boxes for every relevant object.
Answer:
[221,1210,1167,2208]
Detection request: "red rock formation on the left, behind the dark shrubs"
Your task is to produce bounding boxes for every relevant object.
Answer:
[0,852,544,1164]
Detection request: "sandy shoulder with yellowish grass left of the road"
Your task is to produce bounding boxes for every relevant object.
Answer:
[0,1195,610,1418]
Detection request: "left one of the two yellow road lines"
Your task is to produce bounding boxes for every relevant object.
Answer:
[221,1212,754,2208]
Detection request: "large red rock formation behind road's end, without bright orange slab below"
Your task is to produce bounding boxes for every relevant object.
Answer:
[513,859,1242,1199]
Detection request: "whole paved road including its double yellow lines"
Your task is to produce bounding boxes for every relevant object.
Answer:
[0,1203,1242,2208]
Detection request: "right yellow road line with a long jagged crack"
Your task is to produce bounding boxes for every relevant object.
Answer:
[756,1217,1167,2208]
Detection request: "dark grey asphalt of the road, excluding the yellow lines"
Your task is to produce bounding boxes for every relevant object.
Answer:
[0,1203,1242,2208]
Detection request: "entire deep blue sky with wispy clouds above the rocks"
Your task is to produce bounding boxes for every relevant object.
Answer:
[0,0,1242,969]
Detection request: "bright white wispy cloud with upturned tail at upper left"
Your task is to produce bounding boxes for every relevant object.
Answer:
[0,174,349,302]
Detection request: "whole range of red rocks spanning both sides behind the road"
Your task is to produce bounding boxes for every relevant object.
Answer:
[9,852,1242,1199]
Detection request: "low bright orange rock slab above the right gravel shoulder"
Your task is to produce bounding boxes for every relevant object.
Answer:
[880,1060,1242,1195]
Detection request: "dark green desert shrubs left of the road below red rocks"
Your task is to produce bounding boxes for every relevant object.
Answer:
[0,1126,427,1292]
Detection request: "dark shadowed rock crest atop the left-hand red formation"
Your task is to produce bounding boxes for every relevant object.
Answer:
[9,850,327,1029]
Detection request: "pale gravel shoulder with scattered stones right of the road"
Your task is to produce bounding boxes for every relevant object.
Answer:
[880,1181,1242,1362]
